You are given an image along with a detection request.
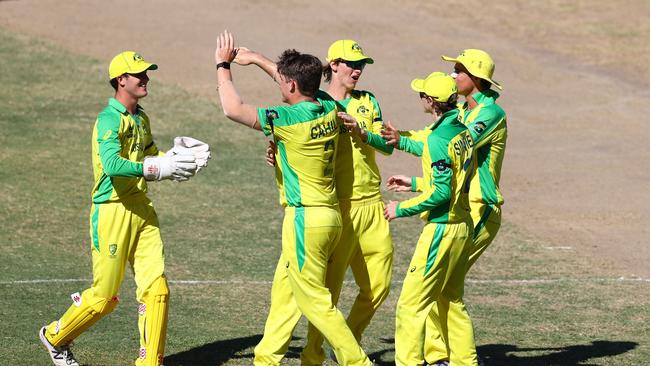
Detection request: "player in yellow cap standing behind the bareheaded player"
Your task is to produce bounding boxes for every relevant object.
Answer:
[242,40,393,365]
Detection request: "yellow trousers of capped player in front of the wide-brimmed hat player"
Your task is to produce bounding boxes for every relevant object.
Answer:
[395,223,477,366]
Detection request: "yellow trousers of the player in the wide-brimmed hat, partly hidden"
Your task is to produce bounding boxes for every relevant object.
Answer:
[424,203,501,364]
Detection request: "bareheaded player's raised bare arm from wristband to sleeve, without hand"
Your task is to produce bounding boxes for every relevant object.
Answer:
[217,68,260,130]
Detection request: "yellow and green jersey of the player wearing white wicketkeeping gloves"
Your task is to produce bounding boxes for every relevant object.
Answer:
[92,98,160,203]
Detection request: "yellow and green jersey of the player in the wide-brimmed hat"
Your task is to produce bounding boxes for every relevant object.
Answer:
[460,89,508,205]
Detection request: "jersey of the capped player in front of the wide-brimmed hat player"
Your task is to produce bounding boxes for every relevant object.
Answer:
[396,109,474,223]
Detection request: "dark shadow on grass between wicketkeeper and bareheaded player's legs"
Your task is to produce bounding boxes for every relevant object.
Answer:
[165,334,302,366]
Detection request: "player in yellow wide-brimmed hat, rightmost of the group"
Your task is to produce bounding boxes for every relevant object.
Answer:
[425,49,508,365]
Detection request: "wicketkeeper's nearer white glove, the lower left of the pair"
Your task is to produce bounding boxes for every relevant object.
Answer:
[142,153,197,182]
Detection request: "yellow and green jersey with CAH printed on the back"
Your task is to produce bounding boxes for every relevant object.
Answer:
[257,92,340,207]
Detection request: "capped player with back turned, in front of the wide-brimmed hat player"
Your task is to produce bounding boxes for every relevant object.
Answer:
[385,73,477,366]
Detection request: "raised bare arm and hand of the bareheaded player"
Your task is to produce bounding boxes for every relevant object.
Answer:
[214,30,262,130]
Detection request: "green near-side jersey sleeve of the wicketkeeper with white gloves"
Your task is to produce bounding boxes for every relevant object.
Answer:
[97,112,142,177]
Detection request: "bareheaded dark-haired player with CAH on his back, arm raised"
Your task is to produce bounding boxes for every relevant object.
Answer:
[215,31,371,365]
